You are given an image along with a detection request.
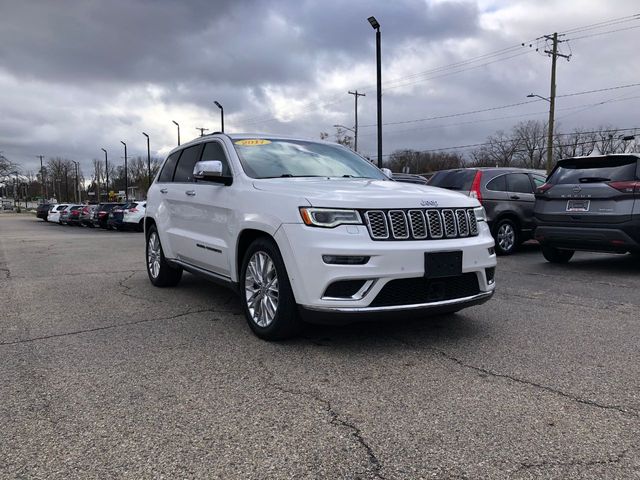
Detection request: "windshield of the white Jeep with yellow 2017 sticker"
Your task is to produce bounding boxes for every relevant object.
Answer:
[233,138,387,180]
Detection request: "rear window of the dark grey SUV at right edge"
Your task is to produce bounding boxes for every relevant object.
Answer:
[549,156,638,185]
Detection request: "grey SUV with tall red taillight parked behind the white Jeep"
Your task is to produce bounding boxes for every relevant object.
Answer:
[429,168,545,255]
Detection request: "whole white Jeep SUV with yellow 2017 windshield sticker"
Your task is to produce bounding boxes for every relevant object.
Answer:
[144,133,496,340]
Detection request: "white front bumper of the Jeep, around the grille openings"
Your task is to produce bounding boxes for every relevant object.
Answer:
[275,222,496,314]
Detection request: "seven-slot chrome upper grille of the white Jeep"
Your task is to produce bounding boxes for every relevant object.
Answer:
[361,208,478,240]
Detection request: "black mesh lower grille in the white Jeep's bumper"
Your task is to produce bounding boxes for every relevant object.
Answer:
[370,272,480,307]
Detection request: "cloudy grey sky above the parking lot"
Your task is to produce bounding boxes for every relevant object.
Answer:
[0,0,640,173]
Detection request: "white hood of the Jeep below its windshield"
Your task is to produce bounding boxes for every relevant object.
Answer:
[253,177,480,209]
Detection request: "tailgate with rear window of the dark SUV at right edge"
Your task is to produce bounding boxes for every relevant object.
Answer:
[536,155,640,224]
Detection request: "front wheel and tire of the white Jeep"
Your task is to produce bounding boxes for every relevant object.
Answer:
[239,237,301,340]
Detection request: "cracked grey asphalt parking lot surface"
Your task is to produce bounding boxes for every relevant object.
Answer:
[0,214,640,479]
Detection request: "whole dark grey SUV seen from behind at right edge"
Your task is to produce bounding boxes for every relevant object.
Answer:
[535,154,640,263]
